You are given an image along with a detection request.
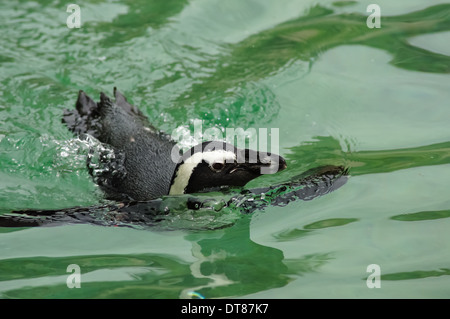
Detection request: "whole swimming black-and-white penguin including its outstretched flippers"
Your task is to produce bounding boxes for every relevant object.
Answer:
[0,89,348,229]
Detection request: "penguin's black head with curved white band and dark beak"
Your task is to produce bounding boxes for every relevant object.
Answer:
[169,141,286,195]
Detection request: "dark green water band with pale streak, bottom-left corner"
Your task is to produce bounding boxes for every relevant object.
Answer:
[0,254,195,298]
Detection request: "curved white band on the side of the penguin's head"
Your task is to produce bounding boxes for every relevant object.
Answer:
[169,150,236,195]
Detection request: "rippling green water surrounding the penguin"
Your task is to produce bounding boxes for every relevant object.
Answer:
[0,0,450,298]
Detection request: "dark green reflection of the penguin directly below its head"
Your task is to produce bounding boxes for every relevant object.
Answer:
[180,218,331,298]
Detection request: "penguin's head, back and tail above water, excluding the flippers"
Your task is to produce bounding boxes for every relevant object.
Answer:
[63,88,286,201]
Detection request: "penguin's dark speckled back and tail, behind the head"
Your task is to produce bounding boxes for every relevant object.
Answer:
[62,88,176,200]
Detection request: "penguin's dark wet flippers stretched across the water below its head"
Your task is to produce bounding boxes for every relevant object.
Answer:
[0,165,348,229]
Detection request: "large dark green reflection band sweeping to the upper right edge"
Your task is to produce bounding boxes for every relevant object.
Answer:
[174,4,450,124]
